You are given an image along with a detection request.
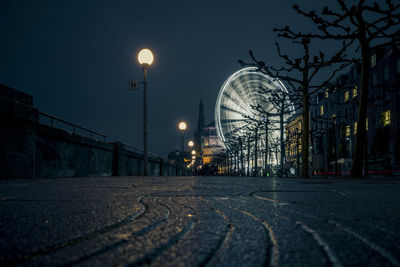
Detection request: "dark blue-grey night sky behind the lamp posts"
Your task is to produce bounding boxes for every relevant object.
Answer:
[0,0,328,156]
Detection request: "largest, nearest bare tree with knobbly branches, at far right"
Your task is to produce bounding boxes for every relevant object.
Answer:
[290,0,400,177]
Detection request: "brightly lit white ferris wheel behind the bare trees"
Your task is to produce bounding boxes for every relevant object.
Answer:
[214,67,294,159]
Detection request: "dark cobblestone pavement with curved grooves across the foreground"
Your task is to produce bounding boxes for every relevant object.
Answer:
[0,177,400,266]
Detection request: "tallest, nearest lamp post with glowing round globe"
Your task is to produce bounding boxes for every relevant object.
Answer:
[138,48,154,176]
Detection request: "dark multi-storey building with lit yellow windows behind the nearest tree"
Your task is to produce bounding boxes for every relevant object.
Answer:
[310,45,400,175]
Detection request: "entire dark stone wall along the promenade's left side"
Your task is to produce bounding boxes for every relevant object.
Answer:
[0,85,190,179]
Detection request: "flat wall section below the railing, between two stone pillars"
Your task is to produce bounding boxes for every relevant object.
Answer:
[36,124,114,178]
